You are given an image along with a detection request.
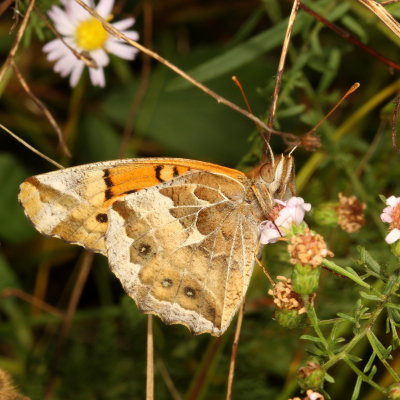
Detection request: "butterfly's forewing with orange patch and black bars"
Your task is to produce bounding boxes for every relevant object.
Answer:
[18,158,243,254]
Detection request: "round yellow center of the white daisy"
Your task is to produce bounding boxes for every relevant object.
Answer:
[75,18,108,51]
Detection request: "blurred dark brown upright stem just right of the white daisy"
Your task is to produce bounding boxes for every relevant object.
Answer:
[119,0,153,156]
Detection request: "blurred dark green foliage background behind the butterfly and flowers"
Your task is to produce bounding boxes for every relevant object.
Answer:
[0,0,400,400]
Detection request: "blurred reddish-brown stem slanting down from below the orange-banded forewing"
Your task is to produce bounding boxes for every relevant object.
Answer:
[44,251,94,400]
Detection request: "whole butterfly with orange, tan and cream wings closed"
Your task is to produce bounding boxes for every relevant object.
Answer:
[18,155,294,336]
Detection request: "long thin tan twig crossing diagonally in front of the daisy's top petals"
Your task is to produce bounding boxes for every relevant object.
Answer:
[75,0,296,139]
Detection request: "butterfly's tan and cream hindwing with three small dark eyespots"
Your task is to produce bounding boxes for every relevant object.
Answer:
[106,171,262,336]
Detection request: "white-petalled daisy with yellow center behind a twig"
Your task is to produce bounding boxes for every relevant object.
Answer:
[43,0,139,87]
